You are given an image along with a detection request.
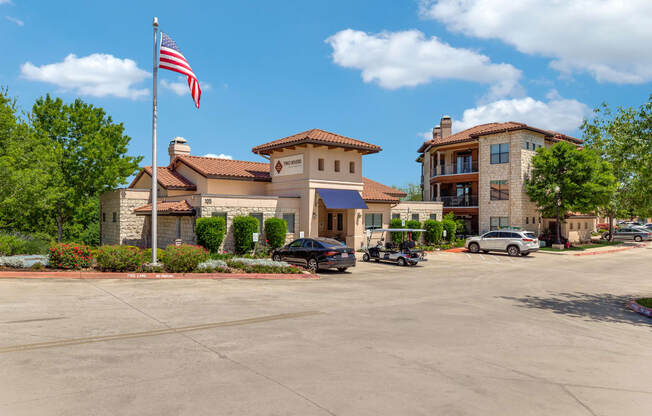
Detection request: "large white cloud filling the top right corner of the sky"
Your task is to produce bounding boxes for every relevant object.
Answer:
[420,0,652,84]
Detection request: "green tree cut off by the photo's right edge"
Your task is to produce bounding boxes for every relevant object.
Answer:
[582,94,652,236]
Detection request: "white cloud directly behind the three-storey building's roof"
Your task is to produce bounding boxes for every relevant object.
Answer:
[453,94,591,133]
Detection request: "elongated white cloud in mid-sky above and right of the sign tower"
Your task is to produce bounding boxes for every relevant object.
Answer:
[326,29,521,97]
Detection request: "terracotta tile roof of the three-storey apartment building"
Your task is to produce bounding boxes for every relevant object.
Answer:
[417,121,584,153]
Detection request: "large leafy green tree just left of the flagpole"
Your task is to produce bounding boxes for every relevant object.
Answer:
[31,94,142,241]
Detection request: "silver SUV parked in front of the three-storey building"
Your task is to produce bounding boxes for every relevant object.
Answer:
[464,230,539,256]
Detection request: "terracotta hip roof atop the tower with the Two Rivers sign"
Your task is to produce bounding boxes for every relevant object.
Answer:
[251,129,382,154]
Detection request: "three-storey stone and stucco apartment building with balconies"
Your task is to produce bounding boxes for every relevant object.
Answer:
[417,116,594,239]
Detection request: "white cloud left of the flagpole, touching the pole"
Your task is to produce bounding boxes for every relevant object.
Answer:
[20,53,151,99]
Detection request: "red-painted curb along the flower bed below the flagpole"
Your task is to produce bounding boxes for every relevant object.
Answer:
[0,271,319,280]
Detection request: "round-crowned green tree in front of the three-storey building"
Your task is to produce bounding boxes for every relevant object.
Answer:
[525,141,615,242]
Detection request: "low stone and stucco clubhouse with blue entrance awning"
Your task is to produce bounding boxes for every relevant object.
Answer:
[100,129,442,250]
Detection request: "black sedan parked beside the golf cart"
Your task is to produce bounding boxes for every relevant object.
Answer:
[272,238,355,272]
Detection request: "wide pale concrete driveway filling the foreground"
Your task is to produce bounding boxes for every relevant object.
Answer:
[0,246,652,416]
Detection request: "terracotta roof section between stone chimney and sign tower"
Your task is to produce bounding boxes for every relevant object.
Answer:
[170,155,271,181]
